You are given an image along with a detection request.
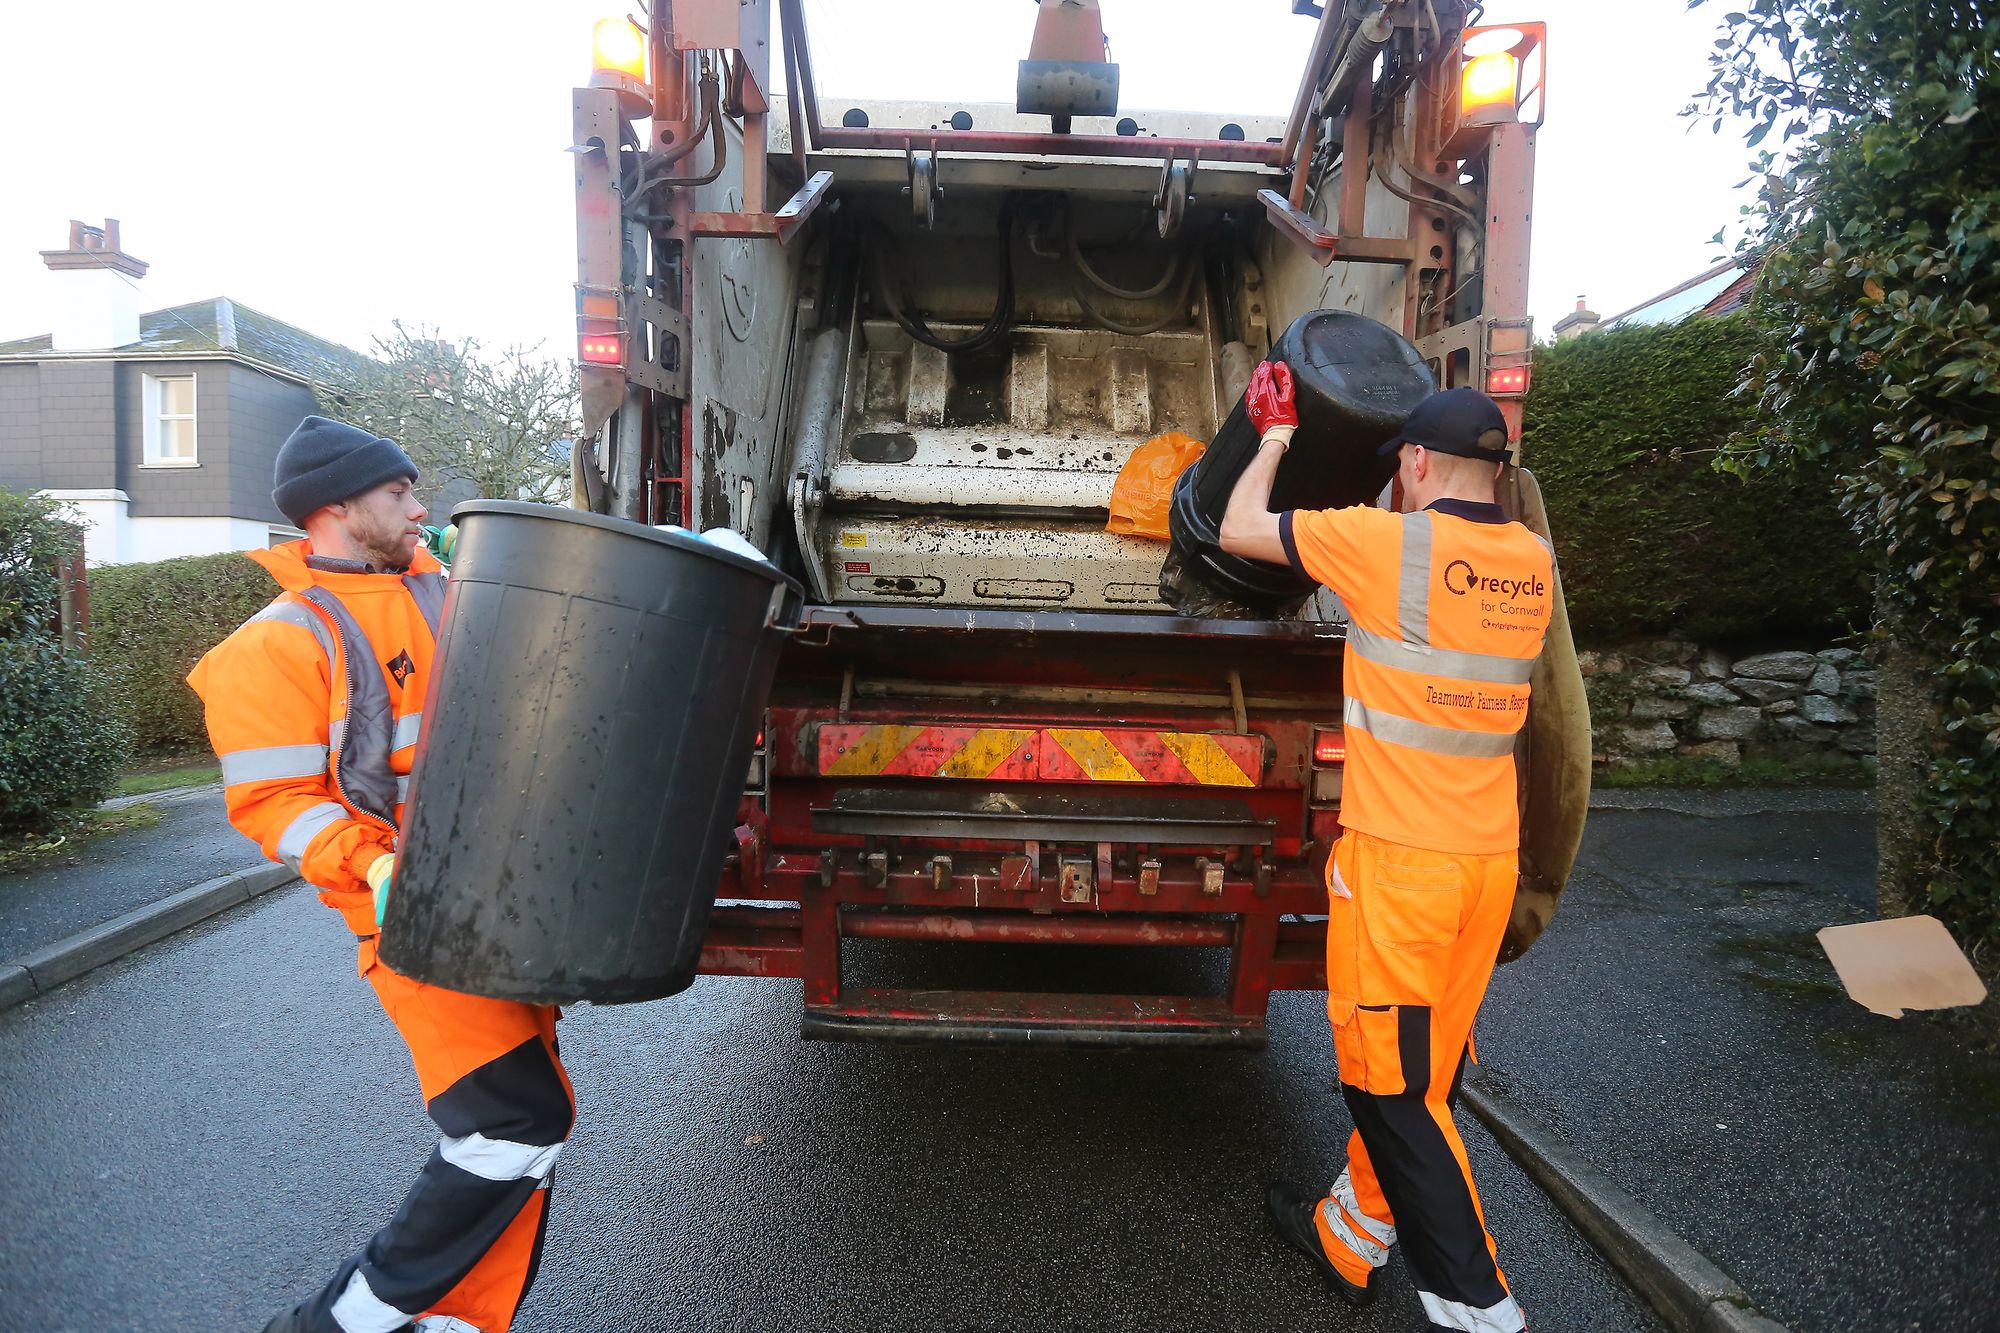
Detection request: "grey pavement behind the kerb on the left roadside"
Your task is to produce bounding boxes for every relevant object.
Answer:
[0,785,264,963]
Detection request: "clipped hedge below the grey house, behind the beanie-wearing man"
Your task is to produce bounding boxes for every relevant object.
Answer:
[90,554,278,751]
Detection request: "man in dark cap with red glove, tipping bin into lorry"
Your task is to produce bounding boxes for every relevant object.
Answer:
[1222,362,1554,1333]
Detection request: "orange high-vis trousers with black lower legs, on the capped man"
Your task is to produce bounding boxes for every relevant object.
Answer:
[1316,831,1526,1333]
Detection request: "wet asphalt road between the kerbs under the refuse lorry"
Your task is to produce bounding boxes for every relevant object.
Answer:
[0,876,1660,1333]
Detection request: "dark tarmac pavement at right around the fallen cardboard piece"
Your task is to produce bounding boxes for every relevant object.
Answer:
[1480,791,2000,1333]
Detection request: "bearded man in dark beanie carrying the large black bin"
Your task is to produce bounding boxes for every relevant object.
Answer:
[188,416,576,1333]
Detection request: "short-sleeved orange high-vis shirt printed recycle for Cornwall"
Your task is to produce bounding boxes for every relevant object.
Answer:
[1278,500,1556,855]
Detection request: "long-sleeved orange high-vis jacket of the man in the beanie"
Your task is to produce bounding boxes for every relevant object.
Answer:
[188,540,444,935]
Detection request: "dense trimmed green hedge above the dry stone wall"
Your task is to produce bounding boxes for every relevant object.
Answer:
[1522,316,1868,646]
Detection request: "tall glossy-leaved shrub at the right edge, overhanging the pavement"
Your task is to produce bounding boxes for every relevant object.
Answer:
[1696,0,2000,945]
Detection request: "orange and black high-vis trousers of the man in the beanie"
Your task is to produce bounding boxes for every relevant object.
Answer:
[304,937,576,1333]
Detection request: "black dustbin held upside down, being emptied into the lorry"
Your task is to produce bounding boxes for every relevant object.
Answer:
[1162,310,1436,614]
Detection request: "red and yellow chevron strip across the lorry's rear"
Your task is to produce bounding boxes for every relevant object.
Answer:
[820,723,1264,787]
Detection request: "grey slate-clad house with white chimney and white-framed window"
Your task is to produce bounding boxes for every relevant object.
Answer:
[0,220,360,564]
